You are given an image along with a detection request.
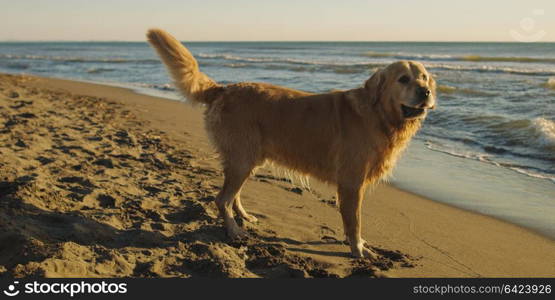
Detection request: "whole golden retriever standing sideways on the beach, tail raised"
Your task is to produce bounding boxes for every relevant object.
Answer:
[147,29,435,258]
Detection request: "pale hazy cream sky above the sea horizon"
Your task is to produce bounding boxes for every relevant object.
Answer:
[0,0,555,42]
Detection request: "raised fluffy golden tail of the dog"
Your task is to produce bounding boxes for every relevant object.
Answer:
[147,29,219,103]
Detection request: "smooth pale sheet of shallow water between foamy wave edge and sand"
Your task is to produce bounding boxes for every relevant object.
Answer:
[391,140,555,240]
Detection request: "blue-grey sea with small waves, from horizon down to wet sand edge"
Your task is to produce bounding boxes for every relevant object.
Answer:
[0,42,555,238]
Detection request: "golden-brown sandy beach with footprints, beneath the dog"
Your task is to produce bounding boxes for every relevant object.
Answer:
[0,75,555,277]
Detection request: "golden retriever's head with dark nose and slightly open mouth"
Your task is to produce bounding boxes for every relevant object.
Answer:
[364,61,436,120]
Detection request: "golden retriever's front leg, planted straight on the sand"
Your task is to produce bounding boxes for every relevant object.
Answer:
[337,184,377,259]
